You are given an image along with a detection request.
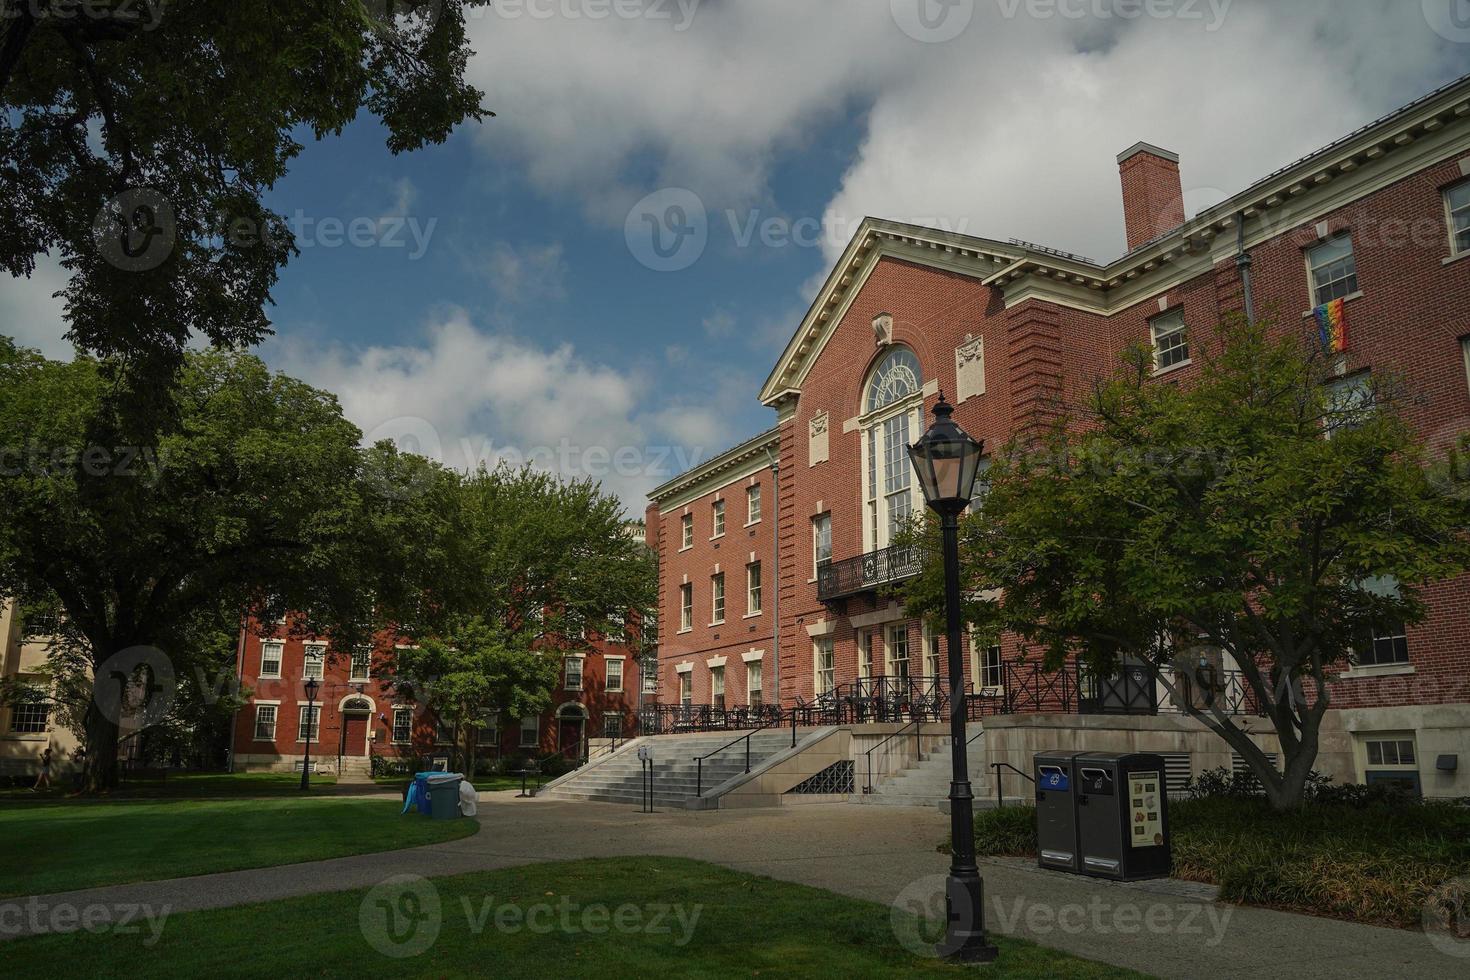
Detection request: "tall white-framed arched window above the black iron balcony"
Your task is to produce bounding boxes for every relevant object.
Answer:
[863,347,923,551]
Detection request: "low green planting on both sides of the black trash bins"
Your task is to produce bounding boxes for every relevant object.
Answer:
[975,798,1470,927]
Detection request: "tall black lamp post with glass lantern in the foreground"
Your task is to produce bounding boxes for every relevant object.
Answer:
[908,395,998,962]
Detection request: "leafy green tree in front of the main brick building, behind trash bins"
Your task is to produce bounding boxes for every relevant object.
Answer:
[911,322,1470,808]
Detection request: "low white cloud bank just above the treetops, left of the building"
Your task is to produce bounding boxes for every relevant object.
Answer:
[268,309,750,514]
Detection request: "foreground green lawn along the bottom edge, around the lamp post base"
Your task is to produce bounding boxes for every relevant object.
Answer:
[4,858,1139,979]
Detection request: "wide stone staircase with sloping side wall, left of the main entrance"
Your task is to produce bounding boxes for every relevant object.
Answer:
[538,730,791,807]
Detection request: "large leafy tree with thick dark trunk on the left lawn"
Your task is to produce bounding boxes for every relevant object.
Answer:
[0,338,453,790]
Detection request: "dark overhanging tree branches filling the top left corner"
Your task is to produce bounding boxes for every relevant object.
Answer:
[0,0,490,376]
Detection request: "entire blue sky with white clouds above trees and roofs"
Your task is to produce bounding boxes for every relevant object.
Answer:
[0,0,1470,513]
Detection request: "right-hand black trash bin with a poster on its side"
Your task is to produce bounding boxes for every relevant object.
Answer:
[1072,752,1173,882]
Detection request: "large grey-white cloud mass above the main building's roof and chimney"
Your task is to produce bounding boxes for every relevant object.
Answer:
[458,0,1464,260]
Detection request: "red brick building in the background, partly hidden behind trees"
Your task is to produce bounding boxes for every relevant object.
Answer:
[231,624,641,773]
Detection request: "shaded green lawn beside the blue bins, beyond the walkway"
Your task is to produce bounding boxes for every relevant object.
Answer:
[0,796,479,896]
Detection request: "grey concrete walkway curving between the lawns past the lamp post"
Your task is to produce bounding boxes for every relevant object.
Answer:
[0,792,1470,980]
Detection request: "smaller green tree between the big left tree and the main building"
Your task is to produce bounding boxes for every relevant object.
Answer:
[394,466,657,764]
